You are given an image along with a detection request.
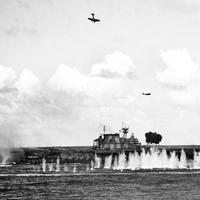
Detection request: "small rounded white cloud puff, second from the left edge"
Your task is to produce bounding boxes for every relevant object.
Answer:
[15,69,41,95]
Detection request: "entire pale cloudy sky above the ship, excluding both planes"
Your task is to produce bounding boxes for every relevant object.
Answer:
[0,0,200,147]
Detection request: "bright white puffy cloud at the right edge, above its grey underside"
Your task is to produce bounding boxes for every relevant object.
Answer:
[156,49,199,87]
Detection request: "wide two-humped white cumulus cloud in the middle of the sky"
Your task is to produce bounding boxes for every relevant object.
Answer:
[48,52,135,103]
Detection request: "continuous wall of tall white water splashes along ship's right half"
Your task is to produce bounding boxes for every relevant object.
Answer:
[100,148,200,171]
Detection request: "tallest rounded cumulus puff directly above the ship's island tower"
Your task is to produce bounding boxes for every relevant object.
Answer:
[85,52,136,101]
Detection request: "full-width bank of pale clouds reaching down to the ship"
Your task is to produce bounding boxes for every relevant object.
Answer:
[0,52,200,146]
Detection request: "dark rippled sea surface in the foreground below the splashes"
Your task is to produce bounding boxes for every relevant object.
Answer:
[0,166,200,200]
